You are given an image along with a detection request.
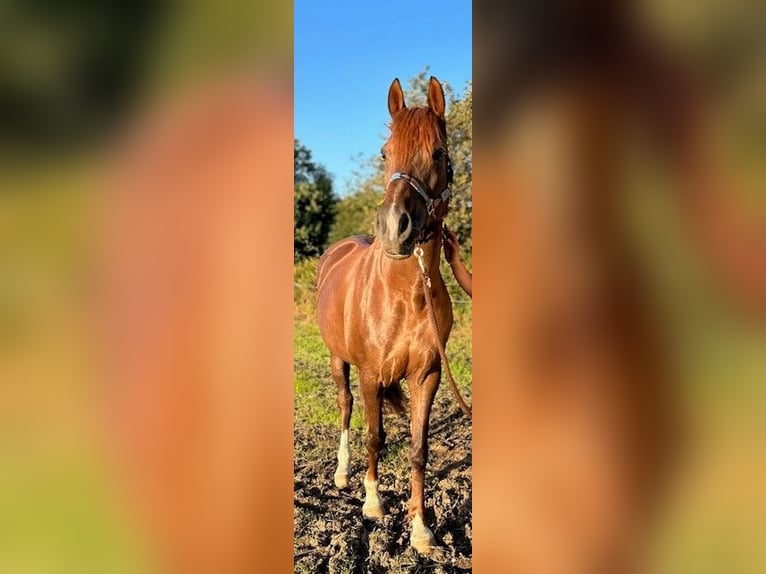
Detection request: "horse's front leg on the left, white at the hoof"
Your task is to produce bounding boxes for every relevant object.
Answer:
[360,373,385,518]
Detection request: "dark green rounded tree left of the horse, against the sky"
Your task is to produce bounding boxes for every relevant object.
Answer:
[293,139,337,261]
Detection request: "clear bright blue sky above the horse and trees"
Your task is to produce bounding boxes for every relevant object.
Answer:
[294,0,472,197]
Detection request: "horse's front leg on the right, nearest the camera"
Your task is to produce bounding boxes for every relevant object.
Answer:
[407,370,441,553]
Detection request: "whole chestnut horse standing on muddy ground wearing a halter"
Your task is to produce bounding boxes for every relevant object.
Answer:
[317,77,460,553]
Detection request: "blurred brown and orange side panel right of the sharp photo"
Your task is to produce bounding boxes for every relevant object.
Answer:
[473,0,766,574]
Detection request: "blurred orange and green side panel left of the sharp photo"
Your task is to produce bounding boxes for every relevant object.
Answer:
[0,1,292,574]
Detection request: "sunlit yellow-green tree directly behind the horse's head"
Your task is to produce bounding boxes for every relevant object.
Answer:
[330,67,473,254]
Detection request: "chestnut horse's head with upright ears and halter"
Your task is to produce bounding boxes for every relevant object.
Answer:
[375,77,452,259]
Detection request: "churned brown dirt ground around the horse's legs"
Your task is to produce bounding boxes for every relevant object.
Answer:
[294,390,472,573]
